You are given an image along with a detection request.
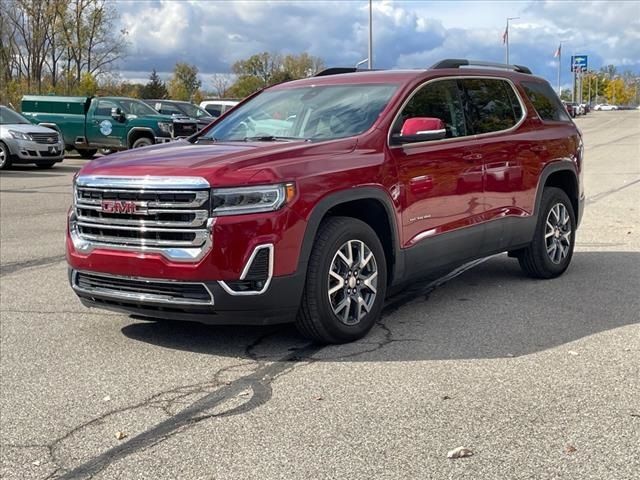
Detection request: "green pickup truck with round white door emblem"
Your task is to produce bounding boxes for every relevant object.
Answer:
[22,95,198,158]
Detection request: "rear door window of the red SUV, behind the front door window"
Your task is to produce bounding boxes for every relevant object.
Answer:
[460,78,523,135]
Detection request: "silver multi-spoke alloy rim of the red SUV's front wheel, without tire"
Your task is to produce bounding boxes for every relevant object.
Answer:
[328,240,378,325]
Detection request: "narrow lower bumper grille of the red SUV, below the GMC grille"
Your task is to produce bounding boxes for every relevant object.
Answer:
[73,272,213,305]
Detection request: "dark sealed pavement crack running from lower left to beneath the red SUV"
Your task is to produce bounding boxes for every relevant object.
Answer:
[3,257,484,479]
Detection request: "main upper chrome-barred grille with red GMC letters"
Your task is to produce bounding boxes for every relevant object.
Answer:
[73,177,211,260]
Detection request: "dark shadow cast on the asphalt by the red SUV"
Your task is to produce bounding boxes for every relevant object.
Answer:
[122,252,640,362]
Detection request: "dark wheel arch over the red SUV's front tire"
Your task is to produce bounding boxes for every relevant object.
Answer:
[298,187,404,285]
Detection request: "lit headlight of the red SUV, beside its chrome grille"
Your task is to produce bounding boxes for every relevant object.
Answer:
[211,183,296,216]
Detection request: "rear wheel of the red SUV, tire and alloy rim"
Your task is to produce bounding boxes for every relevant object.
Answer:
[517,187,576,278]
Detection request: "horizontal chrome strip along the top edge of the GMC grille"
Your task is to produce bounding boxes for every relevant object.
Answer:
[75,175,211,189]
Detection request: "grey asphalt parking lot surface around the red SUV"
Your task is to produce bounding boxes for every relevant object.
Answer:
[0,111,640,480]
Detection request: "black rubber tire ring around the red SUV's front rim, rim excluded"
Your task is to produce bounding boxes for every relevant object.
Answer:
[306,217,387,343]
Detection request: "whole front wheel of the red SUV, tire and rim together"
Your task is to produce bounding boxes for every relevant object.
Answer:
[296,217,387,343]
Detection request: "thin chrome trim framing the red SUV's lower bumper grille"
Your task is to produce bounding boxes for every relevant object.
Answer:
[71,270,215,306]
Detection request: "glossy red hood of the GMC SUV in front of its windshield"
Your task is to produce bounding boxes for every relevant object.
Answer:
[80,138,357,186]
